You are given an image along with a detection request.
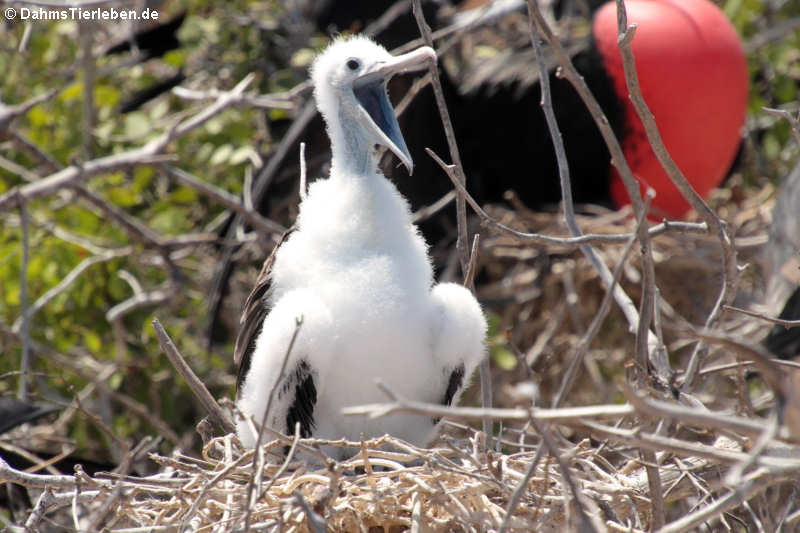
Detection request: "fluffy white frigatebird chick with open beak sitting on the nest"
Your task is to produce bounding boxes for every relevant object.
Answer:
[234,36,486,458]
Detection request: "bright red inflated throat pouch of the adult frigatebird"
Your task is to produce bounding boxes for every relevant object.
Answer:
[592,0,748,218]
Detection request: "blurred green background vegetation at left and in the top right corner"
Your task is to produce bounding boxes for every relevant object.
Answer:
[0,0,800,468]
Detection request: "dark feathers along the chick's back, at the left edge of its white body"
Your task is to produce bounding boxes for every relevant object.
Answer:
[233,227,295,396]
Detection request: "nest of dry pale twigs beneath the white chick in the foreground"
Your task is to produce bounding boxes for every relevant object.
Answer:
[4,408,800,532]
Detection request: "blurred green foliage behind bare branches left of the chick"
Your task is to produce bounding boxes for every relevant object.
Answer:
[0,0,304,458]
